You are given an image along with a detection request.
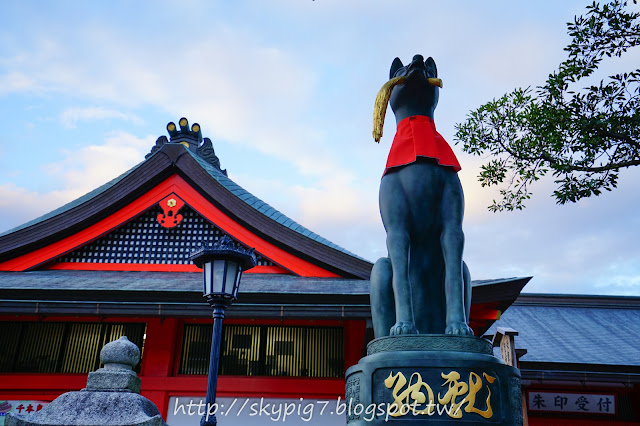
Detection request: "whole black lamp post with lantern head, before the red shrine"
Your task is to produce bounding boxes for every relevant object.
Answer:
[191,235,256,426]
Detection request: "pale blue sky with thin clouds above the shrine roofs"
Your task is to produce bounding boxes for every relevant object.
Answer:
[0,0,640,295]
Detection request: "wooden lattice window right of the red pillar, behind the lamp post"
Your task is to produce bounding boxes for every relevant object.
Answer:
[179,324,344,377]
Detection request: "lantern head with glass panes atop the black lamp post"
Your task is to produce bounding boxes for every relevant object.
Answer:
[191,235,256,306]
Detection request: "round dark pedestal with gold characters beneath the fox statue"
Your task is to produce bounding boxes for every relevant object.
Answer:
[345,335,522,426]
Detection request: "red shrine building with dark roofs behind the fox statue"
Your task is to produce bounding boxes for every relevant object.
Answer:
[0,118,640,426]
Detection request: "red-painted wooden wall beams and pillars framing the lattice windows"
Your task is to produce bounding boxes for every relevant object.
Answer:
[0,316,365,418]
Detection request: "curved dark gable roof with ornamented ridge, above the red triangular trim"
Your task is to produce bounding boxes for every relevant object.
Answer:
[0,119,373,279]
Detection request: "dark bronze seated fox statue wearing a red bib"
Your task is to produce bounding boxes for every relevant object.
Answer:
[371,55,473,337]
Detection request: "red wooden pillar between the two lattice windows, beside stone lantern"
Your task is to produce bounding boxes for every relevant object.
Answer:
[140,318,182,419]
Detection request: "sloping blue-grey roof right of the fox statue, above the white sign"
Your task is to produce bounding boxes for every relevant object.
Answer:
[485,295,640,368]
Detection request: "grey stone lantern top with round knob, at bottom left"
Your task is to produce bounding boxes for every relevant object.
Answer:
[5,336,166,426]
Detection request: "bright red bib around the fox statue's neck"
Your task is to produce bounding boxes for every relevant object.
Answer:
[383,115,461,176]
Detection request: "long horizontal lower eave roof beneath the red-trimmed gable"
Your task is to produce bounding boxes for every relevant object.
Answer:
[0,270,529,332]
